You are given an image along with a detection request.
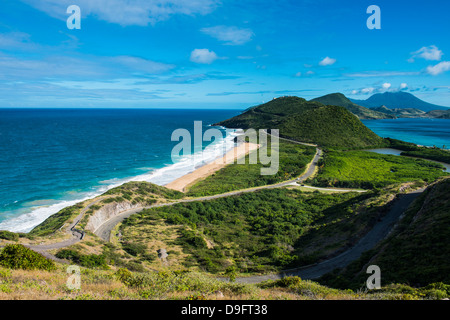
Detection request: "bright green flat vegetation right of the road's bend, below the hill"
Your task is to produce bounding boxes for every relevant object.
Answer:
[311,151,447,189]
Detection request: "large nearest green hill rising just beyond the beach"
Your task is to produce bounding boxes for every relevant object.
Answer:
[217,97,383,148]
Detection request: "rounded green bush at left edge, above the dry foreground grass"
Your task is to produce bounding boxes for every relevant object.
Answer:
[0,244,56,271]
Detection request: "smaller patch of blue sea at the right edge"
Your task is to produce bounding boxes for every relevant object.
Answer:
[362,118,450,149]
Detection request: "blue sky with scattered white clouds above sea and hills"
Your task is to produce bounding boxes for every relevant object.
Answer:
[0,0,450,109]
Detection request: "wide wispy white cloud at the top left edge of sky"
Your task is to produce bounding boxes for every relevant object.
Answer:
[22,0,218,26]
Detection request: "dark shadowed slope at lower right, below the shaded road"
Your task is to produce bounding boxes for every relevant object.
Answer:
[321,179,450,291]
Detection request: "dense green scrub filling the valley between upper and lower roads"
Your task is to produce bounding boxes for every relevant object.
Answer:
[121,189,390,272]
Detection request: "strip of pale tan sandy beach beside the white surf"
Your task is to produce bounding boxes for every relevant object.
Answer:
[165,142,260,192]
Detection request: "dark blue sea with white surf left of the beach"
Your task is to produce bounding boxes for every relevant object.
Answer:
[0,109,240,231]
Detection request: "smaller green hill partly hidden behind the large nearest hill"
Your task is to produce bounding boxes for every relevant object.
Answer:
[311,93,396,119]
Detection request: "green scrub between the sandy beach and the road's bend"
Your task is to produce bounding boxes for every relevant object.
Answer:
[187,140,316,196]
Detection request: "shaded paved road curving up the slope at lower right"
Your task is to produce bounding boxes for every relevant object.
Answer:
[236,189,425,283]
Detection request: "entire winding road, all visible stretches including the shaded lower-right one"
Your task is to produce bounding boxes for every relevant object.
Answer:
[7,132,424,283]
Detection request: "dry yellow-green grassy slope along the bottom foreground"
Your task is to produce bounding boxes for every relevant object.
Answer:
[0,266,446,300]
